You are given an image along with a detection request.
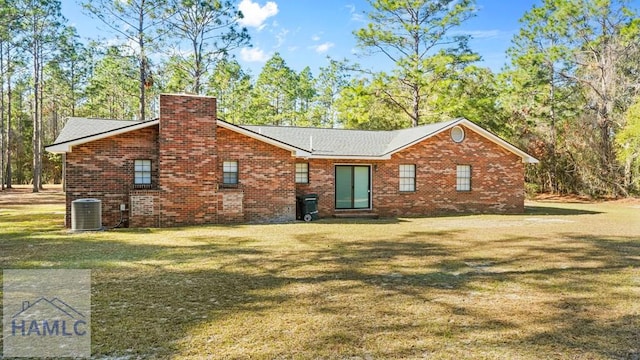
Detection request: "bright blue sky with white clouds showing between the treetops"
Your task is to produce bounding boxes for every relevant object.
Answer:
[62,0,540,76]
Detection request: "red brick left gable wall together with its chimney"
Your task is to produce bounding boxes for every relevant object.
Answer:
[66,95,295,227]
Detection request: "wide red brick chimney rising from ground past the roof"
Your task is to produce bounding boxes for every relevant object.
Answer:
[158,94,218,227]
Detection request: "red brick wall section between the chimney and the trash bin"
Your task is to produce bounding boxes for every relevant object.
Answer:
[218,128,296,222]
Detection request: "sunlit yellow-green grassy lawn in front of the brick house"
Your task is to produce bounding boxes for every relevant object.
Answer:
[0,187,640,359]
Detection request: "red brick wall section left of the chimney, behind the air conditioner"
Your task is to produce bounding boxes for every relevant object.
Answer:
[65,126,158,227]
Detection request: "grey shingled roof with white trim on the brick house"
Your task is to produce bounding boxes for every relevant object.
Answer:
[46,118,537,163]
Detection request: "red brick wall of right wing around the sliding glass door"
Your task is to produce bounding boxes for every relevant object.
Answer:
[296,128,524,217]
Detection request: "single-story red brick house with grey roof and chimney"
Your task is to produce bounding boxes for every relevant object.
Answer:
[46,95,537,227]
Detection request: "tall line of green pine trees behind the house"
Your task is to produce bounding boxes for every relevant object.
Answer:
[0,0,640,196]
